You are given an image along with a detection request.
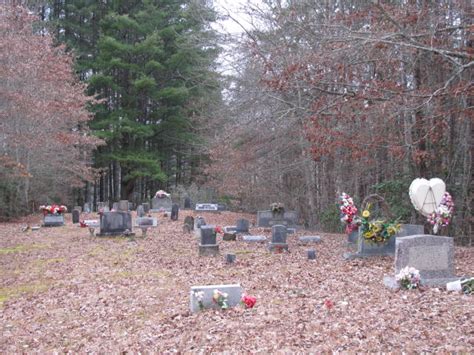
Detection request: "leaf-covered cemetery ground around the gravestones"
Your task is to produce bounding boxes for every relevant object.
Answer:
[0,211,474,353]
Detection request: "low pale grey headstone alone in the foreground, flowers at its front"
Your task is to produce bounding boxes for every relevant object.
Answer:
[189,284,242,313]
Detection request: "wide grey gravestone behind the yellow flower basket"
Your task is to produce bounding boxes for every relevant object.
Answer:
[344,224,424,260]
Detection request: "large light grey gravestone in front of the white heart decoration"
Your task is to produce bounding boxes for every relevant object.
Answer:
[384,234,458,288]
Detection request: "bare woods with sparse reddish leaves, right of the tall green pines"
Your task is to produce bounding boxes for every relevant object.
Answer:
[209,0,474,242]
